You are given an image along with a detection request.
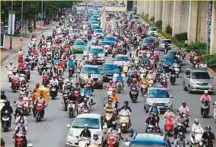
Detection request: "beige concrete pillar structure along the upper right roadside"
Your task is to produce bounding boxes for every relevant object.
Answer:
[136,0,216,53]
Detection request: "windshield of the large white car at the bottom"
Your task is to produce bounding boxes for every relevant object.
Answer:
[72,118,100,129]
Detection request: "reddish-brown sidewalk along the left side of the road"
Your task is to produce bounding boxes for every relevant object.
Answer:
[0,21,50,62]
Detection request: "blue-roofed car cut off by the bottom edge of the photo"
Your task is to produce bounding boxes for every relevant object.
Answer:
[124,133,171,147]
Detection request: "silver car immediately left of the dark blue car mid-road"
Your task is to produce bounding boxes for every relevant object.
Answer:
[79,65,103,89]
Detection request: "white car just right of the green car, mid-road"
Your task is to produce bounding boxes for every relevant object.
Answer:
[88,46,106,64]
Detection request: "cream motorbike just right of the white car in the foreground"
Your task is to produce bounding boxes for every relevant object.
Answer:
[104,110,116,128]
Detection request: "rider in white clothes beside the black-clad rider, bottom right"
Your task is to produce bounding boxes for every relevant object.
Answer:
[192,118,204,145]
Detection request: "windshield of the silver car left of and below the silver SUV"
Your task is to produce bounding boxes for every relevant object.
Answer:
[149,89,169,98]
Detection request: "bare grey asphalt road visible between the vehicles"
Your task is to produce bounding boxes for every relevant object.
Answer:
[1,24,216,147]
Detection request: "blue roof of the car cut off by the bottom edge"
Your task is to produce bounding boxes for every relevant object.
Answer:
[131,133,167,145]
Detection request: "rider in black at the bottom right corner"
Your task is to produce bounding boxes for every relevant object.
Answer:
[202,126,216,147]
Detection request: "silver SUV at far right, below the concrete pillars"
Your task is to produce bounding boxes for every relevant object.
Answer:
[183,68,214,93]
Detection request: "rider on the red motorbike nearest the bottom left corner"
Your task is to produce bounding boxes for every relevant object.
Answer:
[14,120,27,147]
